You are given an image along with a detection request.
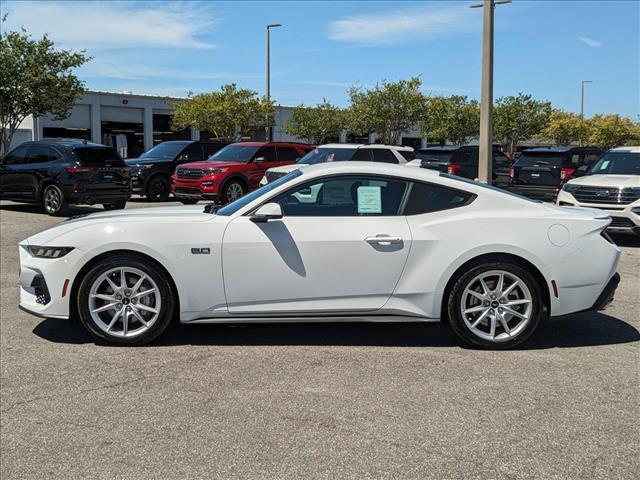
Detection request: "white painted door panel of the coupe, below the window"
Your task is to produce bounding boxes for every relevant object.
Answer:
[222,217,411,314]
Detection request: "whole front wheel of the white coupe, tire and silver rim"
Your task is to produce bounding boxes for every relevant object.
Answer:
[78,255,175,345]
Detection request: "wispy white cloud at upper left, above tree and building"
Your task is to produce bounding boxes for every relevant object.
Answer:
[5,2,215,52]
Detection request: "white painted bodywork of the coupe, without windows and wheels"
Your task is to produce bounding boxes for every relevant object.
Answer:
[21,162,619,322]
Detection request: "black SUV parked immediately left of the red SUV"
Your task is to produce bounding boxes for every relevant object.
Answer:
[126,140,227,202]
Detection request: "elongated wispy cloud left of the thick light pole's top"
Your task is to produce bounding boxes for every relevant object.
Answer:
[327,2,481,46]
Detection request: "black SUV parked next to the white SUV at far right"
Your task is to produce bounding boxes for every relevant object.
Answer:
[508,147,603,202]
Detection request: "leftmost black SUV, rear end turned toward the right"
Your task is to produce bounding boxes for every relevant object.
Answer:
[0,139,131,215]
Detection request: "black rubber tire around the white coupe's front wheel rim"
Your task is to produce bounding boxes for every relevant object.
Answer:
[77,254,176,346]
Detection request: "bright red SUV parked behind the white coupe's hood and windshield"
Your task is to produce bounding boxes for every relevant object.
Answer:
[171,142,315,204]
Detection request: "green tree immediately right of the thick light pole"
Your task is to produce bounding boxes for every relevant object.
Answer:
[493,93,552,152]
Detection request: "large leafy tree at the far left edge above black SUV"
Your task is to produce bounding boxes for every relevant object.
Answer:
[0,22,90,154]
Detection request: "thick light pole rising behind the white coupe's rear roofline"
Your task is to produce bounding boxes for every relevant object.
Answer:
[471,0,511,184]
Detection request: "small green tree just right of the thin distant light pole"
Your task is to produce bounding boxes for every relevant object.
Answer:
[284,100,347,145]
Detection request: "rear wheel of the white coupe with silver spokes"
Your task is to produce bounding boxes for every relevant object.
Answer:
[447,262,544,349]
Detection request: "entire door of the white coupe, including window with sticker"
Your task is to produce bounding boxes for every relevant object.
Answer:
[222,175,411,315]
